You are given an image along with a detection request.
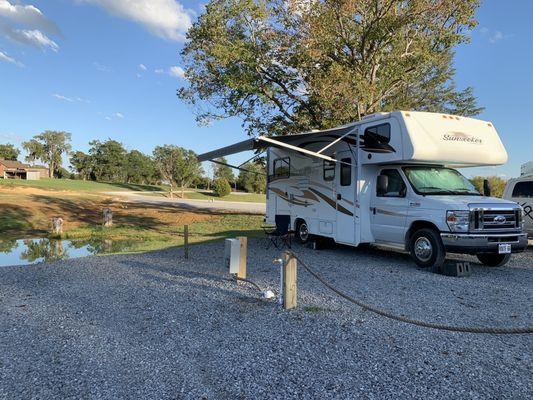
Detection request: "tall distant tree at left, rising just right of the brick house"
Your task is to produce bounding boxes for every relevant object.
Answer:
[22,131,71,178]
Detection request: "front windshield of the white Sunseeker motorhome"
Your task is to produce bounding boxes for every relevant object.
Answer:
[403,167,481,196]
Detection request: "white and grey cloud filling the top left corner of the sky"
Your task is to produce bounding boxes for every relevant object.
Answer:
[0,0,61,52]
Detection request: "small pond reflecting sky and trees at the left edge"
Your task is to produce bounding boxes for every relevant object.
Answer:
[0,239,139,267]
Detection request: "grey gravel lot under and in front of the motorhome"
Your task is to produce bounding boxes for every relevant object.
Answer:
[0,241,533,399]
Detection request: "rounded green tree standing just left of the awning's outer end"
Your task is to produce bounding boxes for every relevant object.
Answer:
[153,145,203,198]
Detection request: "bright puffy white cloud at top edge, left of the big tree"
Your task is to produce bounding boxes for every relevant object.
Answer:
[81,0,192,41]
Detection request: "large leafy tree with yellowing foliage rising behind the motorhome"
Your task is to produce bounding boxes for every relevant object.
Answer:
[178,0,481,134]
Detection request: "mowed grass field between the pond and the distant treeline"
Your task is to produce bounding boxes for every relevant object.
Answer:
[0,180,263,251]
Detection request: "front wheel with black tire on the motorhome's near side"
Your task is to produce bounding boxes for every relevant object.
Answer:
[409,228,446,268]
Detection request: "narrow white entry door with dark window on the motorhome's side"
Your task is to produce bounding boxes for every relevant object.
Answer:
[335,151,357,244]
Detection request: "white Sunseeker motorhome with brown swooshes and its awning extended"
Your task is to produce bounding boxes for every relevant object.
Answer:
[199,111,527,267]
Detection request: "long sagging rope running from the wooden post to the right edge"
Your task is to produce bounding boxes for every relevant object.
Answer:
[289,251,533,335]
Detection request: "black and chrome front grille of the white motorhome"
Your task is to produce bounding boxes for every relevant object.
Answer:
[471,209,522,232]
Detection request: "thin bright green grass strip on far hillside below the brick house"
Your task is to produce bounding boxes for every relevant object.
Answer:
[0,179,165,192]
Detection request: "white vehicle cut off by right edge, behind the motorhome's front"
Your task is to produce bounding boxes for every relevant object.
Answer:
[503,161,533,237]
